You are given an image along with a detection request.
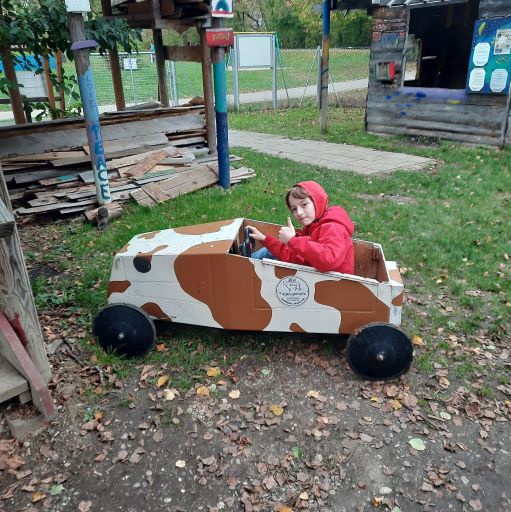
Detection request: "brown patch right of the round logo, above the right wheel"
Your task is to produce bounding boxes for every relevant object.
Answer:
[314,280,390,334]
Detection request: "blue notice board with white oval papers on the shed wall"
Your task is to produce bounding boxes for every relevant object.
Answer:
[466,18,511,94]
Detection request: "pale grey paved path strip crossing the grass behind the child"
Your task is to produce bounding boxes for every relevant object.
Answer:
[229,130,435,175]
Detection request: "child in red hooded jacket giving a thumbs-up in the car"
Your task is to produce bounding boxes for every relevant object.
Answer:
[247,181,355,274]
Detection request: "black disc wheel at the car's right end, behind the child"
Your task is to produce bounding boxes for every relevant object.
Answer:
[346,323,413,380]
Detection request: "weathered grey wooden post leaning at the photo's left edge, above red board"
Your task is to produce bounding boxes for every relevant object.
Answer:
[0,165,50,382]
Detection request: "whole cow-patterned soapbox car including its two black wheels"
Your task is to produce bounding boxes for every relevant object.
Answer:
[93,218,413,380]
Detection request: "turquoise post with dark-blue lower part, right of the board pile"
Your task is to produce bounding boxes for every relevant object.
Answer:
[213,48,231,189]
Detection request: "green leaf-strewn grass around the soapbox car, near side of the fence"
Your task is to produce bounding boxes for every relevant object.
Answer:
[24,108,511,388]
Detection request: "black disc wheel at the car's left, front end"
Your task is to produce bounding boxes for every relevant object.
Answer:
[93,304,156,357]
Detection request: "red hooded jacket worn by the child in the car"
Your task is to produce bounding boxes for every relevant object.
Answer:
[263,181,355,274]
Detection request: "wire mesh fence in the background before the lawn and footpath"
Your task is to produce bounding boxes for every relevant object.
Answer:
[86,48,369,112]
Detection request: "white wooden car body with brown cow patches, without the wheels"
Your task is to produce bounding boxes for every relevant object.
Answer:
[108,218,403,334]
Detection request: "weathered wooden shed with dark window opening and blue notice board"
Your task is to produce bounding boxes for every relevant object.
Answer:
[366,0,511,146]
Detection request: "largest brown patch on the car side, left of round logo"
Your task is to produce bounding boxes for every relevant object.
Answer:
[174,246,272,331]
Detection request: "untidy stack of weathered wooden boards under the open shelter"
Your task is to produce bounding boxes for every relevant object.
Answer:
[0,106,255,218]
